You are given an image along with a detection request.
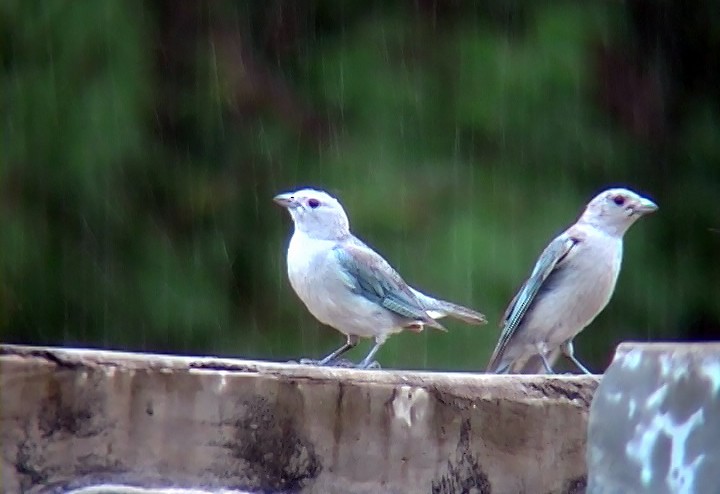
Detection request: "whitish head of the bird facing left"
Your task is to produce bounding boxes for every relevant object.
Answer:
[273,189,350,240]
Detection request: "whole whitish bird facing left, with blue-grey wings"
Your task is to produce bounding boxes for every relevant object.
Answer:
[273,188,487,369]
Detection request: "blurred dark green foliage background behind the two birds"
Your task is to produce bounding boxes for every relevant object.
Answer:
[0,0,720,370]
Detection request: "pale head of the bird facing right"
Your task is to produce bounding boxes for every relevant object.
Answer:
[580,189,658,236]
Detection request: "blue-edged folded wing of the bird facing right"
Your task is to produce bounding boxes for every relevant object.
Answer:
[488,233,580,369]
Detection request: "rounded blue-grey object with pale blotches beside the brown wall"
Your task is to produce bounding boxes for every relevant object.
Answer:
[588,343,720,494]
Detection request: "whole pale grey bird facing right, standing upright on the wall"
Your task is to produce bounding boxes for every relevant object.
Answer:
[486,188,658,374]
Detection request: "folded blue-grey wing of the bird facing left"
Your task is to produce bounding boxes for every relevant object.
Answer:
[333,243,444,329]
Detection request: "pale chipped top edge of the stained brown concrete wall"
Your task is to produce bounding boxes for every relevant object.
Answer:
[0,344,602,406]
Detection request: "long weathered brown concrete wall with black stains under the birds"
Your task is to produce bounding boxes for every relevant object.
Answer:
[0,346,597,494]
